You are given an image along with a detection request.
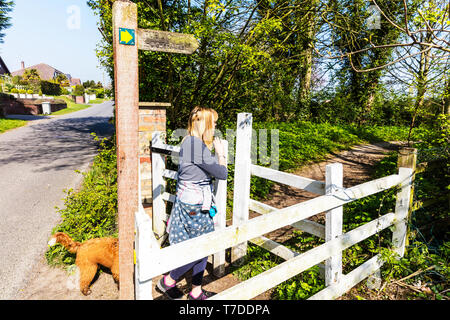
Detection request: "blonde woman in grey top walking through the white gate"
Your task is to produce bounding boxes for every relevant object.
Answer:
[157,107,228,300]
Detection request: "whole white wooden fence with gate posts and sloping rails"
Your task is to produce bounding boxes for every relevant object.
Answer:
[135,113,413,300]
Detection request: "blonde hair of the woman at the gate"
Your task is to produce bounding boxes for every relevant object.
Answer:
[187,106,219,150]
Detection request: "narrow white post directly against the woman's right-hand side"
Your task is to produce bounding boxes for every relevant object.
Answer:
[213,140,228,277]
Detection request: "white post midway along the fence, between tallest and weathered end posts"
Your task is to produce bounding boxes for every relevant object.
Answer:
[325,163,344,286]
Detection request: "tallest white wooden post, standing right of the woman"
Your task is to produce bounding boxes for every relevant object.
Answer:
[231,113,252,265]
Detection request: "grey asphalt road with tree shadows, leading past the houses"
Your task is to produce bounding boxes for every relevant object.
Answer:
[0,102,114,299]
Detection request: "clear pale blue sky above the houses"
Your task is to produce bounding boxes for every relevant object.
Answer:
[0,0,111,84]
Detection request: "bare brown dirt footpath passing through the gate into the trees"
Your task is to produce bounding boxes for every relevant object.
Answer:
[16,142,399,300]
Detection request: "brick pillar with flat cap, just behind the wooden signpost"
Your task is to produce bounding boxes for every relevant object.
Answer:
[139,102,170,217]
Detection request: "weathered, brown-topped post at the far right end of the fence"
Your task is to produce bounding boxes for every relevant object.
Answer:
[392,148,417,257]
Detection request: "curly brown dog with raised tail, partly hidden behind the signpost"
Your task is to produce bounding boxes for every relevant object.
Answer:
[48,232,119,295]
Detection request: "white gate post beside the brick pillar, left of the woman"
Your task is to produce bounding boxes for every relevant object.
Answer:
[152,131,166,238]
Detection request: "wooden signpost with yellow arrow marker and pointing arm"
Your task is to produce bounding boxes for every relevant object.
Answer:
[112,0,198,300]
